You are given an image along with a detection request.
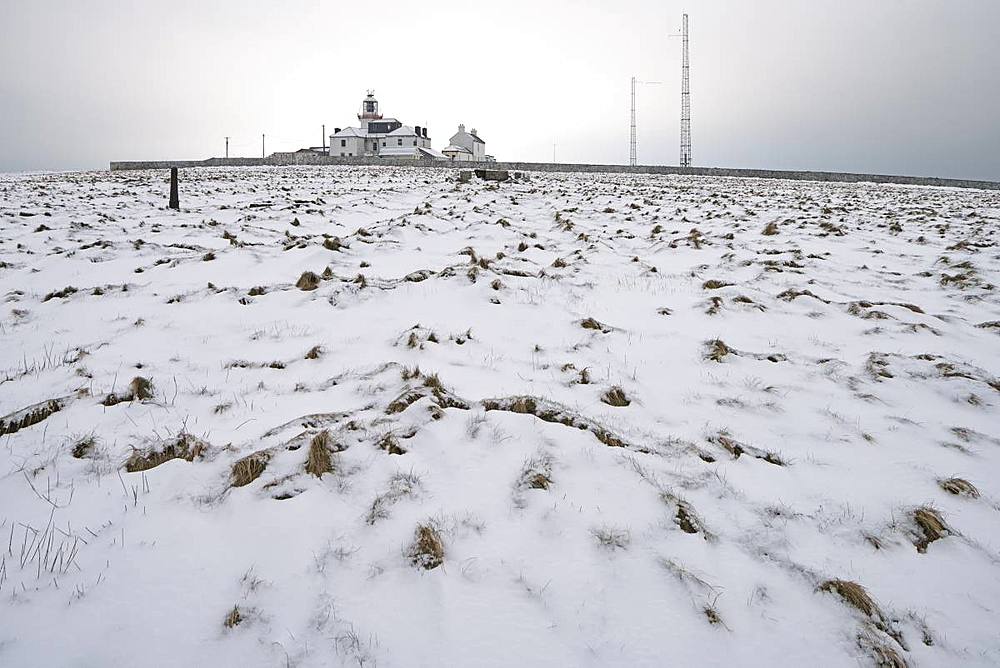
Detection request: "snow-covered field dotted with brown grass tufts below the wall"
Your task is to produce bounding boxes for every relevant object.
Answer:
[0,168,1000,666]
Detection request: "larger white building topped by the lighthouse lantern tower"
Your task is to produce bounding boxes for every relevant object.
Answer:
[330,91,445,160]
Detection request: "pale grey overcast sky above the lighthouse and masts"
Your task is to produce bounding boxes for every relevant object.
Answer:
[0,0,1000,180]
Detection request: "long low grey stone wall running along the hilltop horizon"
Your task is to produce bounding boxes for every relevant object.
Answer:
[111,153,1000,190]
